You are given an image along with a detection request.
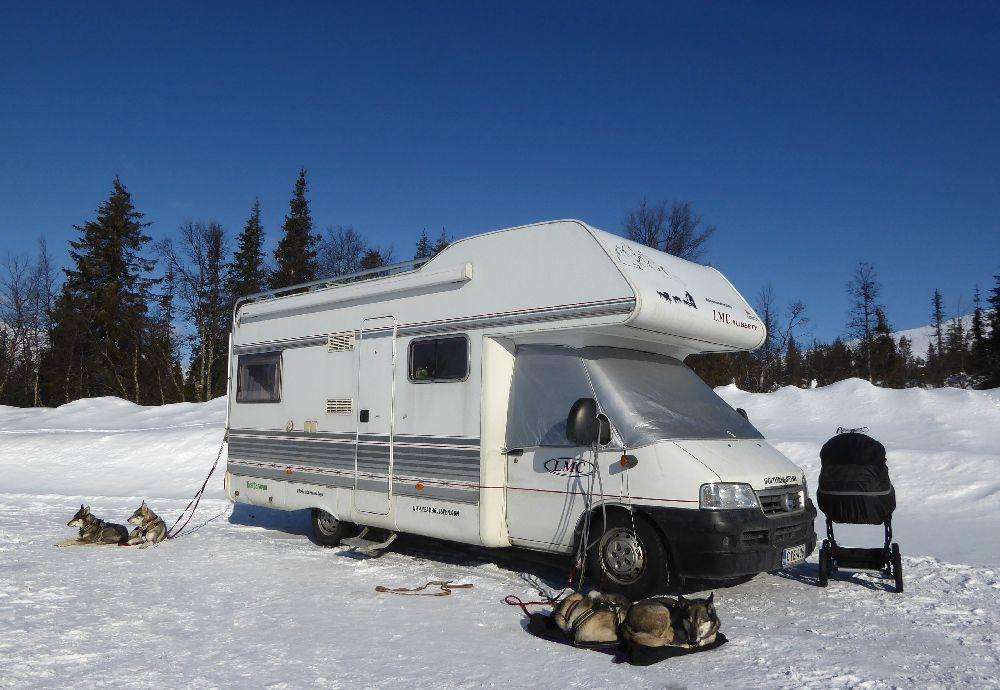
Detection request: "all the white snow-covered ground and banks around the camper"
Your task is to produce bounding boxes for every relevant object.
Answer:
[0,380,1000,688]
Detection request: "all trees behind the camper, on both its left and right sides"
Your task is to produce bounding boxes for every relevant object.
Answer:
[0,185,1000,406]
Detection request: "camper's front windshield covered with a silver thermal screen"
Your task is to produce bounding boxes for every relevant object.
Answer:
[579,347,763,448]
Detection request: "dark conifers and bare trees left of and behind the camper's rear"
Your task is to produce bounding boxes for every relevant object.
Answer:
[0,170,450,406]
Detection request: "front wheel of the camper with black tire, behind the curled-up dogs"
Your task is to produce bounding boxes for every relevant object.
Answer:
[583,510,671,601]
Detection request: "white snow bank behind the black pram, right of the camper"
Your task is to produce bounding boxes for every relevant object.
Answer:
[716,379,1000,566]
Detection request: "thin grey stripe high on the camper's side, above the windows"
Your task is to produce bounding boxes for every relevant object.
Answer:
[233,297,635,354]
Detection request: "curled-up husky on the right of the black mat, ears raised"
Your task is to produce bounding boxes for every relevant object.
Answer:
[622,592,719,648]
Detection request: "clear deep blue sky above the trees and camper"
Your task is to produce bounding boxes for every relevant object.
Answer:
[0,2,1000,338]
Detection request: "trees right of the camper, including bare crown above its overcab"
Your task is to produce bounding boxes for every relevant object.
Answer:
[622,200,1000,392]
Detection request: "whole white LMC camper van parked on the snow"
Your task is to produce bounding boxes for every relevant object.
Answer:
[225,220,816,595]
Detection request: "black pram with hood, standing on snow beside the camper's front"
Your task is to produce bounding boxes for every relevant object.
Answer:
[816,428,903,592]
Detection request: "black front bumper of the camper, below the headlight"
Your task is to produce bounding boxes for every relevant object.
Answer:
[641,499,816,580]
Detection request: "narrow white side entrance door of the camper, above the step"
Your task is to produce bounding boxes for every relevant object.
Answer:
[354,316,396,515]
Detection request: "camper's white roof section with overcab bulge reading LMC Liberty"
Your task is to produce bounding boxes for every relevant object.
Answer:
[234,220,765,357]
